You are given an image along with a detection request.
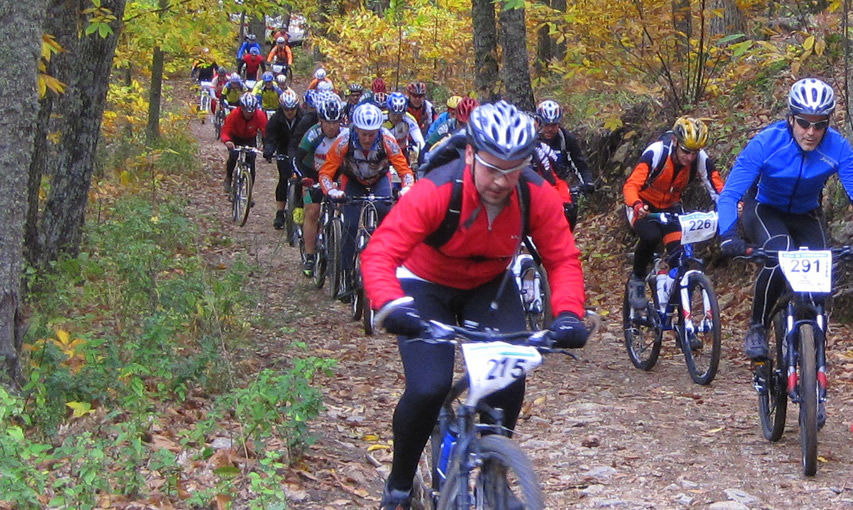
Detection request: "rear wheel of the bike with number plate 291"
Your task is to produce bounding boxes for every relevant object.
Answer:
[755,311,788,441]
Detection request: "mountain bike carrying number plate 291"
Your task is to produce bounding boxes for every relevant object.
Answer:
[746,246,853,476]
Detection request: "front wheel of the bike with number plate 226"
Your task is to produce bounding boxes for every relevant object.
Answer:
[673,273,720,385]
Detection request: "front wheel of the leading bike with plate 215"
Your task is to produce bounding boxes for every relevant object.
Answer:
[436,435,545,510]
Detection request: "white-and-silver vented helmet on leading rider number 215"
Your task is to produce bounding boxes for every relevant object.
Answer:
[466,101,537,161]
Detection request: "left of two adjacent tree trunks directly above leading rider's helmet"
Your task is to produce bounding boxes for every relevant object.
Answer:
[471,0,498,100]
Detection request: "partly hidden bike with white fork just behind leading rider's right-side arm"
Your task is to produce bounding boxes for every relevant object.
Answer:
[510,236,554,331]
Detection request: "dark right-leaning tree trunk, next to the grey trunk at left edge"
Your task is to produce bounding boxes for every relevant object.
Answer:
[39,0,126,263]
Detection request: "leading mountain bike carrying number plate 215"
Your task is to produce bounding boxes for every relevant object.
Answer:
[402,314,600,510]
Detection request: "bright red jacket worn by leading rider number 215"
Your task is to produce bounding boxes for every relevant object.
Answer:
[361,163,585,317]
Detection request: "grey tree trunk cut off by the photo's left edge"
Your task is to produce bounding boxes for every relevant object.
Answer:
[0,0,47,388]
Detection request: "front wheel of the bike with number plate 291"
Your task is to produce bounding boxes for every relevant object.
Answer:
[799,324,817,476]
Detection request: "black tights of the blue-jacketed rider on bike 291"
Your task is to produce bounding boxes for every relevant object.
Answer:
[743,199,827,324]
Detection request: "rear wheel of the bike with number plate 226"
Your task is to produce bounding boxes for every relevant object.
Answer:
[622,276,663,370]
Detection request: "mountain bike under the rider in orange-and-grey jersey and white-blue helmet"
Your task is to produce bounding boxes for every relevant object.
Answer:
[348,194,394,335]
